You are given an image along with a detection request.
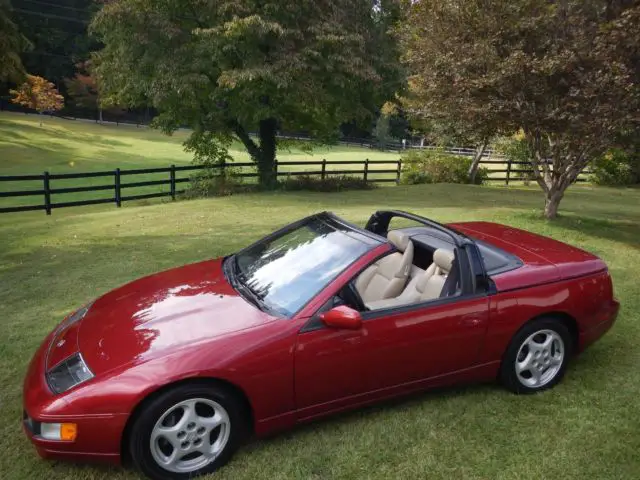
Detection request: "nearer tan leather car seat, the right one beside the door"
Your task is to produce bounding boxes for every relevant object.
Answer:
[365,248,454,310]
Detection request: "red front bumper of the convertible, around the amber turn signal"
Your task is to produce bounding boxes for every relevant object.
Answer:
[22,334,128,463]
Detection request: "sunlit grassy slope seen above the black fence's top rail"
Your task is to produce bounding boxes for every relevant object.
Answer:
[0,112,398,175]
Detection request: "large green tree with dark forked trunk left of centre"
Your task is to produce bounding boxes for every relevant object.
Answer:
[92,0,402,187]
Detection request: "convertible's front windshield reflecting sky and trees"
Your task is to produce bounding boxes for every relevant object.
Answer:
[235,217,380,316]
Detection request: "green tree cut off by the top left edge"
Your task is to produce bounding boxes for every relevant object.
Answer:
[0,0,31,83]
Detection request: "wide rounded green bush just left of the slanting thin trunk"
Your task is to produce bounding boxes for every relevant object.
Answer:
[402,149,488,185]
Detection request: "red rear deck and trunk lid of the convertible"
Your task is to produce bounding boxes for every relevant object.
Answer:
[451,222,607,290]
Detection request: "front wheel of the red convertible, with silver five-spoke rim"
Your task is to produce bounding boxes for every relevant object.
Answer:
[129,383,249,480]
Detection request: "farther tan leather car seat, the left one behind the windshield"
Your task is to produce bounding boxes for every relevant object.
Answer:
[356,230,413,304]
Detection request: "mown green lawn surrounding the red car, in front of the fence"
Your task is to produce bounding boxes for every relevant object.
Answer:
[0,184,640,480]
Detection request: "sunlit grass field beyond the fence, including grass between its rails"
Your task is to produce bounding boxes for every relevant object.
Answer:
[0,112,399,207]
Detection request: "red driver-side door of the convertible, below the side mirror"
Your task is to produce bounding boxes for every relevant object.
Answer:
[295,256,489,419]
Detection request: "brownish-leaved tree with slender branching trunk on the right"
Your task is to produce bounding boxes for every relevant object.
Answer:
[403,0,640,218]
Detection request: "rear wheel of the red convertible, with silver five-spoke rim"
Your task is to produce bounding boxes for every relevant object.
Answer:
[500,317,573,394]
